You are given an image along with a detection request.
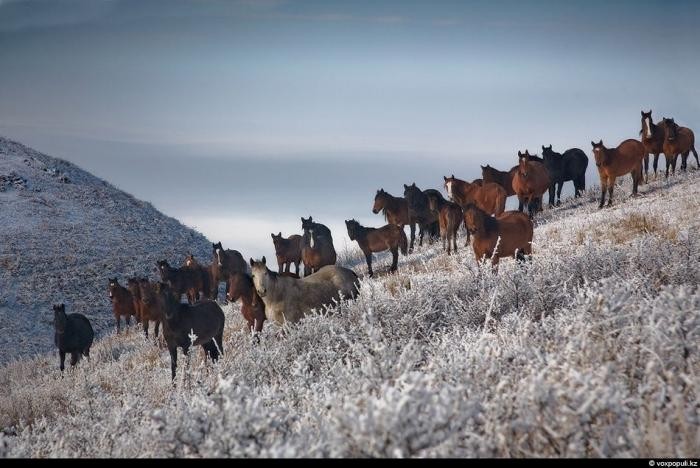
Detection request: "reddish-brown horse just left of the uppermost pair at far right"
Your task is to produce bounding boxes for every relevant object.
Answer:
[591,139,647,208]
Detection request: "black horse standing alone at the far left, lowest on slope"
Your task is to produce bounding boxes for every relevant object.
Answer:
[53,304,95,372]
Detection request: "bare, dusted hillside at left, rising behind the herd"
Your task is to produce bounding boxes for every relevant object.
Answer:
[0,137,211,362]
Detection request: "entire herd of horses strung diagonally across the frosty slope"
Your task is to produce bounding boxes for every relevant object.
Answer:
[54,111,700,380]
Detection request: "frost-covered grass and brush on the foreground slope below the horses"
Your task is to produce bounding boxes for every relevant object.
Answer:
[0,157,700,457]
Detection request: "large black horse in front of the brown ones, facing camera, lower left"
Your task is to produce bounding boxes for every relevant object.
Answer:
[154,283,225,380]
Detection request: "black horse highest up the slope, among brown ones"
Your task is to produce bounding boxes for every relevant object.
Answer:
[542,145,588,208]
